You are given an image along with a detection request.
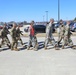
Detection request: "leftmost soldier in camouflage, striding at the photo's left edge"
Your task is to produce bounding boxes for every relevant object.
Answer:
[0,24,11,48]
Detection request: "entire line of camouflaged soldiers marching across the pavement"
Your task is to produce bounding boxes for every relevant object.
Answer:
[0,19,74,51]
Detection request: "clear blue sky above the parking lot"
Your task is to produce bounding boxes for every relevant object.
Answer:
[0,0,76,22]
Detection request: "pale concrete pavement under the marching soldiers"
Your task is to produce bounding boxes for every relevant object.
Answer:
[0,36,76,75]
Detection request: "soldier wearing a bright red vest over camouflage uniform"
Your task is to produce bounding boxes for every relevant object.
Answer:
[27,21,38,50]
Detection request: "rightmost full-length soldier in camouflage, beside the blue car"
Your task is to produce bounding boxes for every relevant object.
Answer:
[64,21,73,47]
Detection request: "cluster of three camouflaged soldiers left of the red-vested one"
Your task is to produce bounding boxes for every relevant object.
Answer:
[0,23,23,51]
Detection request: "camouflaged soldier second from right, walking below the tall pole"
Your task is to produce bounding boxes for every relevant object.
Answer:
[57,20,65,49]
